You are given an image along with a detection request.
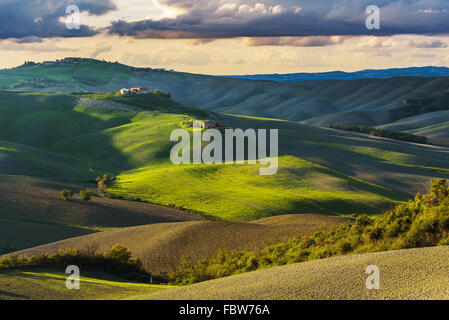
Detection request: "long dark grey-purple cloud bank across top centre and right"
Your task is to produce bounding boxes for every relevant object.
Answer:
[109,0,449,39]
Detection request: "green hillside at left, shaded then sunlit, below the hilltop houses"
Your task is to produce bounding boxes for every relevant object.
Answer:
[0,92,196,174]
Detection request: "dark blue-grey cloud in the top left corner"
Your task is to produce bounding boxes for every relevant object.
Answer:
[0,0,116,39]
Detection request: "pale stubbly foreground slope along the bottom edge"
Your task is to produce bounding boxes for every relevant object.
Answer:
[6,247,449,300]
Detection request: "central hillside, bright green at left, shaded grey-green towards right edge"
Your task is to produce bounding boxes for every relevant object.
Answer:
[112,112,449,219]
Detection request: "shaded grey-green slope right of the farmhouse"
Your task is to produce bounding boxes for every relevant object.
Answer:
[214,115,449,201]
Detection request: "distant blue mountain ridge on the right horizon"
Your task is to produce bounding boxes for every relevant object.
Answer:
[223,66,449,82]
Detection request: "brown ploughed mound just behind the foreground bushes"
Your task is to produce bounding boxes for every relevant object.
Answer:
[9,215,347,274]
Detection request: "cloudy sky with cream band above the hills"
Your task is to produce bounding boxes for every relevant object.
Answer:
[0,0,449,75]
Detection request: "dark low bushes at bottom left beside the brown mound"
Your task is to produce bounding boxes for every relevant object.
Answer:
[0,243,151,282]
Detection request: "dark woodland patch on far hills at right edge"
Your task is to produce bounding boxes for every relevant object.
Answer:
[388,93,449,121]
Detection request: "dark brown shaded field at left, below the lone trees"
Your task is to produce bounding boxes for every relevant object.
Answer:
[0,175,199,254]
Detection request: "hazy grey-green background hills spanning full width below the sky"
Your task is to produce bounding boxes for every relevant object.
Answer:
[0,61,449,126]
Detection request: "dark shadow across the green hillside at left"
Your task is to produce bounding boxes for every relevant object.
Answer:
[0,92,150,181]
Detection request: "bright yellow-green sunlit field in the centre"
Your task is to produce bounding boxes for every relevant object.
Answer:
[110,156,400,220]
